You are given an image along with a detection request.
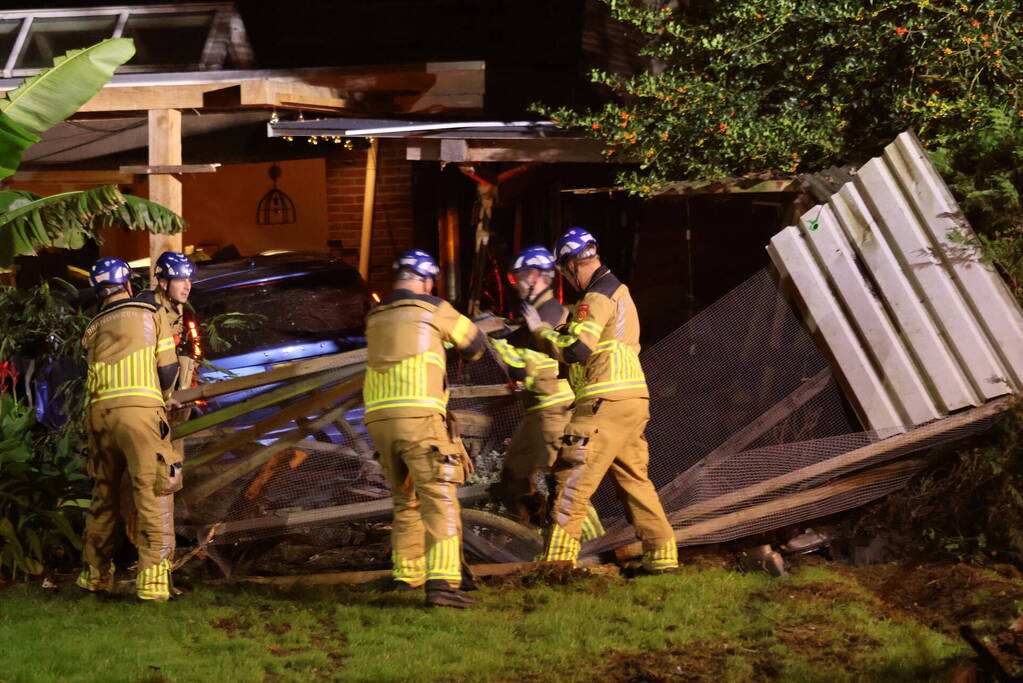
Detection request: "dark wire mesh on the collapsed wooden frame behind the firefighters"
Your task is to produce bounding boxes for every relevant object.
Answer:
[178,270,998,561]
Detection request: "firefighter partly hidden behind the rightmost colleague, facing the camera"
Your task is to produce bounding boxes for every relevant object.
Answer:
[491,246,604,541]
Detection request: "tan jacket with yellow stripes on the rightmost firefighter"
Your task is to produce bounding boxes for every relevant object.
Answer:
[533,266,650,401]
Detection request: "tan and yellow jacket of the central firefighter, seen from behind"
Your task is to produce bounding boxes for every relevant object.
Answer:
[362,289,486,422]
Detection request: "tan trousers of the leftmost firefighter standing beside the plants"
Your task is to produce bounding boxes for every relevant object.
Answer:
[82,403,181,600]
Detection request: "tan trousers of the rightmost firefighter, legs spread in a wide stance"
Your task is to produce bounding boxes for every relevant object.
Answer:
[543,398,678,572]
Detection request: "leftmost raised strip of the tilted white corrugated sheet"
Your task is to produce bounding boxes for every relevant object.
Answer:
[767,226,906,438]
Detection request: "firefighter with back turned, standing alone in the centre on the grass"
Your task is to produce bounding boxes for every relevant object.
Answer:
[362,249,486,608]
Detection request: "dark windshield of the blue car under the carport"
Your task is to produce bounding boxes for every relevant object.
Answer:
[192,270,368,358]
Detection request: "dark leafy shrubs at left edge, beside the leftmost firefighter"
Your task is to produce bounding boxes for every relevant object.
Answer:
[0,280,89,578]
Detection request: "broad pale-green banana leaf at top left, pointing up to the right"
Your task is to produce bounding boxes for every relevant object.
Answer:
[0,38,135,138]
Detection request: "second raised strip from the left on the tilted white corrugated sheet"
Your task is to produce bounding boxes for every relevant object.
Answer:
[799,204,945,424]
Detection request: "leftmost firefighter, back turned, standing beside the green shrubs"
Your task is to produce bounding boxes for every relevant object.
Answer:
[77,259,181,601]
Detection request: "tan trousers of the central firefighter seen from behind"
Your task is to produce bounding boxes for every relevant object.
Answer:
[366,414,469,588]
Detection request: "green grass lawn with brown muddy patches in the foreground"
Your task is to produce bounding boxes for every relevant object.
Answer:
[0,560,1023,682]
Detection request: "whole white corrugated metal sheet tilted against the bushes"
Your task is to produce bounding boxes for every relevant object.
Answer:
[768,127,1023,432]
